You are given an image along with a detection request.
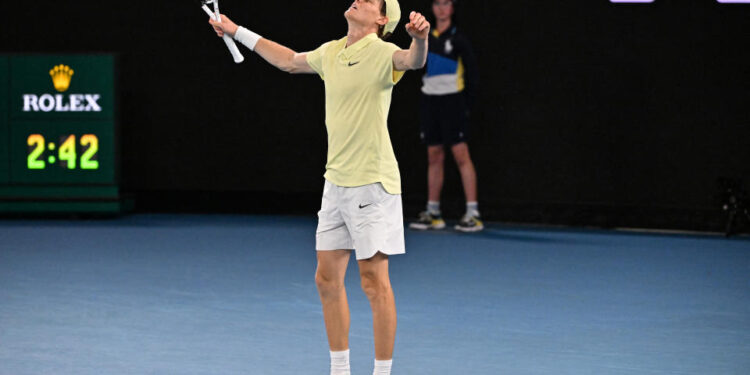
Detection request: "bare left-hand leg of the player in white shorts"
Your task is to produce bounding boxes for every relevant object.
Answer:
[315,250,351,352]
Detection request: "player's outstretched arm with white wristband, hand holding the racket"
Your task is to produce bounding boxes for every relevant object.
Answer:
[208,14,315,73]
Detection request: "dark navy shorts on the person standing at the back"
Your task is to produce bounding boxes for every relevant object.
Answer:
[419,93,469,146]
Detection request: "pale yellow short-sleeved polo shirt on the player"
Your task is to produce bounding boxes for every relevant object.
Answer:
[307,33,404,194]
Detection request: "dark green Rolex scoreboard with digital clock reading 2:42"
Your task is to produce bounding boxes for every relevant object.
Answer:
[0,55,120,213]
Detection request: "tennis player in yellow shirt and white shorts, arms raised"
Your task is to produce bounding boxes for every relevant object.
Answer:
[209,0,430,375]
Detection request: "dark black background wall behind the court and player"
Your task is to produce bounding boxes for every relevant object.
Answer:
[0,0,750,229]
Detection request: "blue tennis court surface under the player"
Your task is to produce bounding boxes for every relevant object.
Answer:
[0,215,750,375]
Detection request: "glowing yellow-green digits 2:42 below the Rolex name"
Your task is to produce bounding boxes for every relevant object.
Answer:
[27,134,99,170]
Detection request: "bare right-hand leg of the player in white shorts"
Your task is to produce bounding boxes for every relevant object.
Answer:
[358,253,396,360]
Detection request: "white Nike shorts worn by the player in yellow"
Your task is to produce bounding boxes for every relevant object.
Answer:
[315,180,406,260]
